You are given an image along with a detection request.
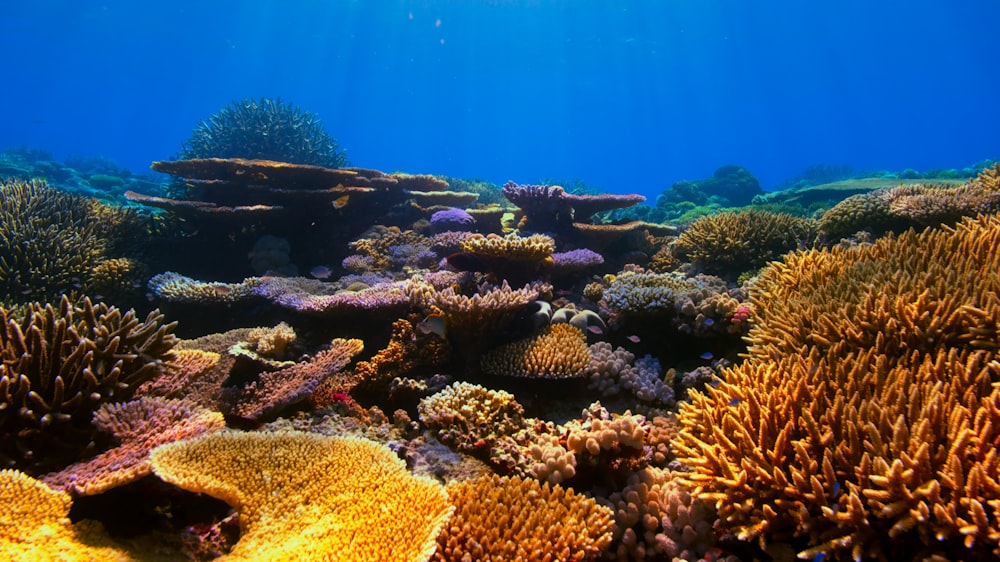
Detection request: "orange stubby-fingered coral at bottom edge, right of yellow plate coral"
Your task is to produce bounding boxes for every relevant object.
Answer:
[432,475,612,562]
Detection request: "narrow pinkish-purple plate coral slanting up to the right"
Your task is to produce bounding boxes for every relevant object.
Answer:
[220,338,364,422]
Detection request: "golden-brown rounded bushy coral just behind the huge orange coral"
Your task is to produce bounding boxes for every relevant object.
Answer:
[675,210,814,278]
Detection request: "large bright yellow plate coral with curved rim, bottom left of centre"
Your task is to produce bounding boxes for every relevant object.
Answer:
[151,431,452,561]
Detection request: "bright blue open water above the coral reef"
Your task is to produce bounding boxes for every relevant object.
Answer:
[0,0,1000,196]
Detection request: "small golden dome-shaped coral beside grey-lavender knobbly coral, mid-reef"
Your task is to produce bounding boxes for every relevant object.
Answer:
[482,324,590,379]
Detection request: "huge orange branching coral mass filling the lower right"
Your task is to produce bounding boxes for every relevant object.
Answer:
[674,212,1000,560]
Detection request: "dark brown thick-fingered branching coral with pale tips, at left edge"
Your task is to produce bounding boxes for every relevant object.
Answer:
[0,296,177,474]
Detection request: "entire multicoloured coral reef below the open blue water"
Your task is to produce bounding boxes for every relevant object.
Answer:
[0,99,1000,561]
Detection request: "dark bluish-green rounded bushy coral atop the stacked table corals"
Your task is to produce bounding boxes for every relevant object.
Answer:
[180,98,347,168]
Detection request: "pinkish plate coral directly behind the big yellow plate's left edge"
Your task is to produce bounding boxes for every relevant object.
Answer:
[41,396,226,496]
